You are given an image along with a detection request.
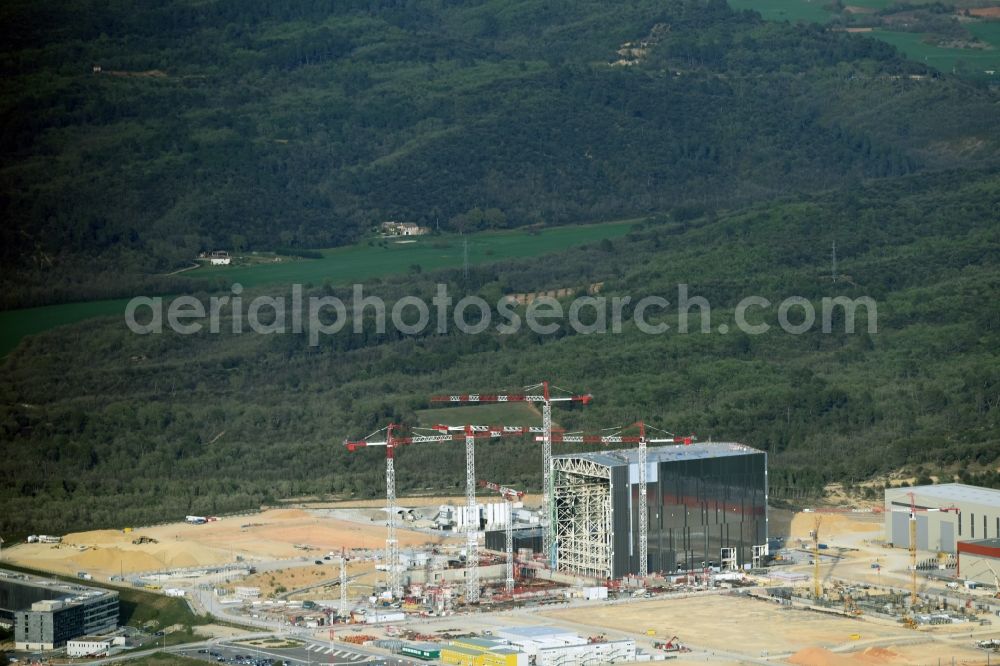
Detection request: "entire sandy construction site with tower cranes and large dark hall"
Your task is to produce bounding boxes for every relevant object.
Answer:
[3,383,1000,666]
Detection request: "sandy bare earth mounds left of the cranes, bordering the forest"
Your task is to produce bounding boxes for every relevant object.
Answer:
[3,509,458,577]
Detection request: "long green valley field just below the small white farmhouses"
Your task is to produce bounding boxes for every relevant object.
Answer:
[185,220,638,287]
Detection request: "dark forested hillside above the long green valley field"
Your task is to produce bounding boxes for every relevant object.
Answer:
[0,0,1000,308]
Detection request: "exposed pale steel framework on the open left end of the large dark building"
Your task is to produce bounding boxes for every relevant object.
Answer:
[552,458,612,578]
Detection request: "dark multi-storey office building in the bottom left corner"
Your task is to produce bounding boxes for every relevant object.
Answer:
[0,571,118,650]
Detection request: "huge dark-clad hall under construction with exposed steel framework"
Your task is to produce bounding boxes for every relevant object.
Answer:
[552,443,767,579]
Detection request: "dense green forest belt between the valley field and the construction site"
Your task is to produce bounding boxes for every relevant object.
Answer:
[0,171,1000,533]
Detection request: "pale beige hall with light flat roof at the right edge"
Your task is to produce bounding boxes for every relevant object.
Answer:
[884,483,1000,553]
